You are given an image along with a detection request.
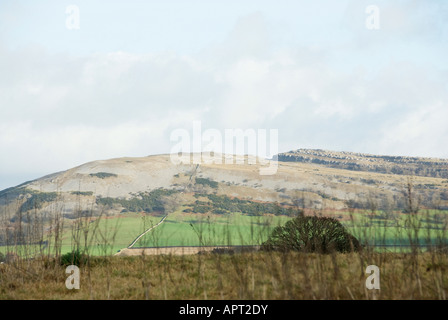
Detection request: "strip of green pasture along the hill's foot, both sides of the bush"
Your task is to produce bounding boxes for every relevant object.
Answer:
[0,208,448,256]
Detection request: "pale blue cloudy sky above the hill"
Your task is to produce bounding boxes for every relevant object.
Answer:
[0,0,448,190]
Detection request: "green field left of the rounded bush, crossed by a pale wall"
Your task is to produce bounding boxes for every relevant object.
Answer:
[31,212,290,255]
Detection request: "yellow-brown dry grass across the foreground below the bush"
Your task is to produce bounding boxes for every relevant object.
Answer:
[0,251,448,300]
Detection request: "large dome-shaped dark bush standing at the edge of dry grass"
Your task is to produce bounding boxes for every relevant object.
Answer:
[262,216,361,253]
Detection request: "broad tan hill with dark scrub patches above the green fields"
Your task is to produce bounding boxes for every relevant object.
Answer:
[0,149,448,221]
